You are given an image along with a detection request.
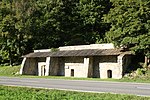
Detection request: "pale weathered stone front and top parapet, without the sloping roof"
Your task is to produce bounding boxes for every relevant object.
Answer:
[20,44,131,79]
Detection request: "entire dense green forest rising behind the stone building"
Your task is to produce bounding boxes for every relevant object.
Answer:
[0,0,150,66]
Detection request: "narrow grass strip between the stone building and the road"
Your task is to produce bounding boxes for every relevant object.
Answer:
[0,66,150,83]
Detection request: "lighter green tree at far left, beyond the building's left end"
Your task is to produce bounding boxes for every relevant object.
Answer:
[0,0,33,65]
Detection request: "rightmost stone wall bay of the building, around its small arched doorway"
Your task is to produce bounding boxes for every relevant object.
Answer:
[99,54,131,79]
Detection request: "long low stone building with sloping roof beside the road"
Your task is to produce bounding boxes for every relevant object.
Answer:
[20,44,131,79]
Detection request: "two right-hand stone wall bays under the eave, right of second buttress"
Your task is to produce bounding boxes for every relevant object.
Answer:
[50,55,130,79]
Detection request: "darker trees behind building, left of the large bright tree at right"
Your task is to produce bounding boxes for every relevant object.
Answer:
[0,0,111,65]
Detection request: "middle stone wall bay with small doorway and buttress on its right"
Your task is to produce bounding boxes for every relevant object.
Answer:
[54,57,93,77]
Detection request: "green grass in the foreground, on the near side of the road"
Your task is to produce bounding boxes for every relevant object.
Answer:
[0,86,150,100]
